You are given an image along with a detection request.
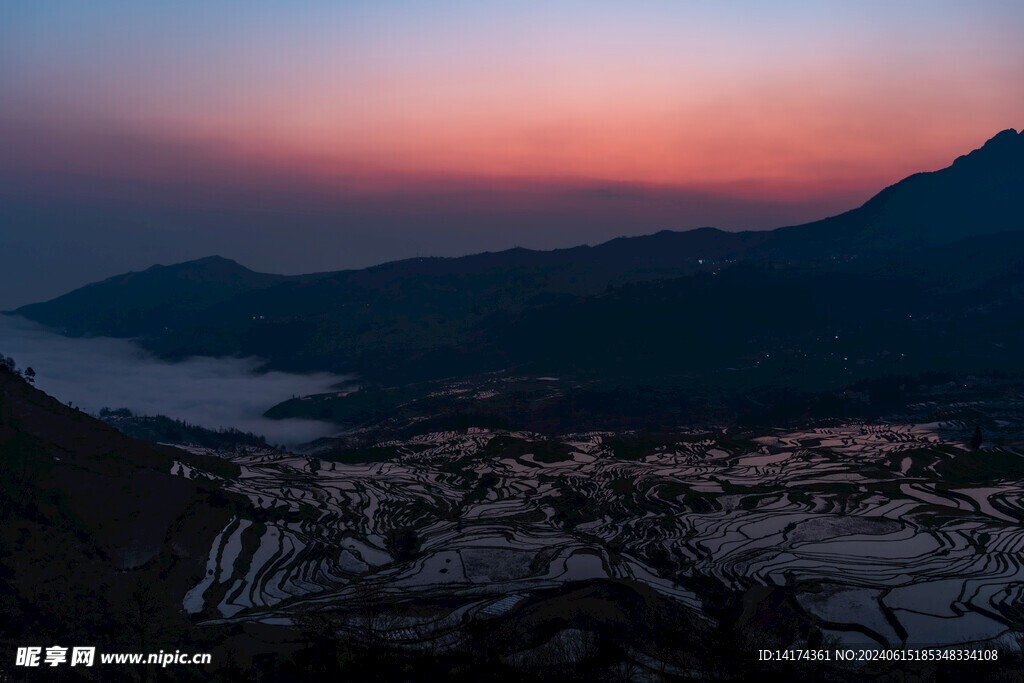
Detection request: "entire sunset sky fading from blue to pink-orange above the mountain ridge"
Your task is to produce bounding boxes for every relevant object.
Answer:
[0,0,1024,307]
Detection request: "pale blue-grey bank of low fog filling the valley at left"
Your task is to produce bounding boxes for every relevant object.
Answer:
[0,314,348,445]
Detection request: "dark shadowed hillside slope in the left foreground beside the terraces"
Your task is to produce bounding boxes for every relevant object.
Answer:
[0,360,237,680]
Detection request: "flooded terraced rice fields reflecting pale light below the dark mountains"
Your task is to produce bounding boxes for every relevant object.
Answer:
[174,423,1024,645]
